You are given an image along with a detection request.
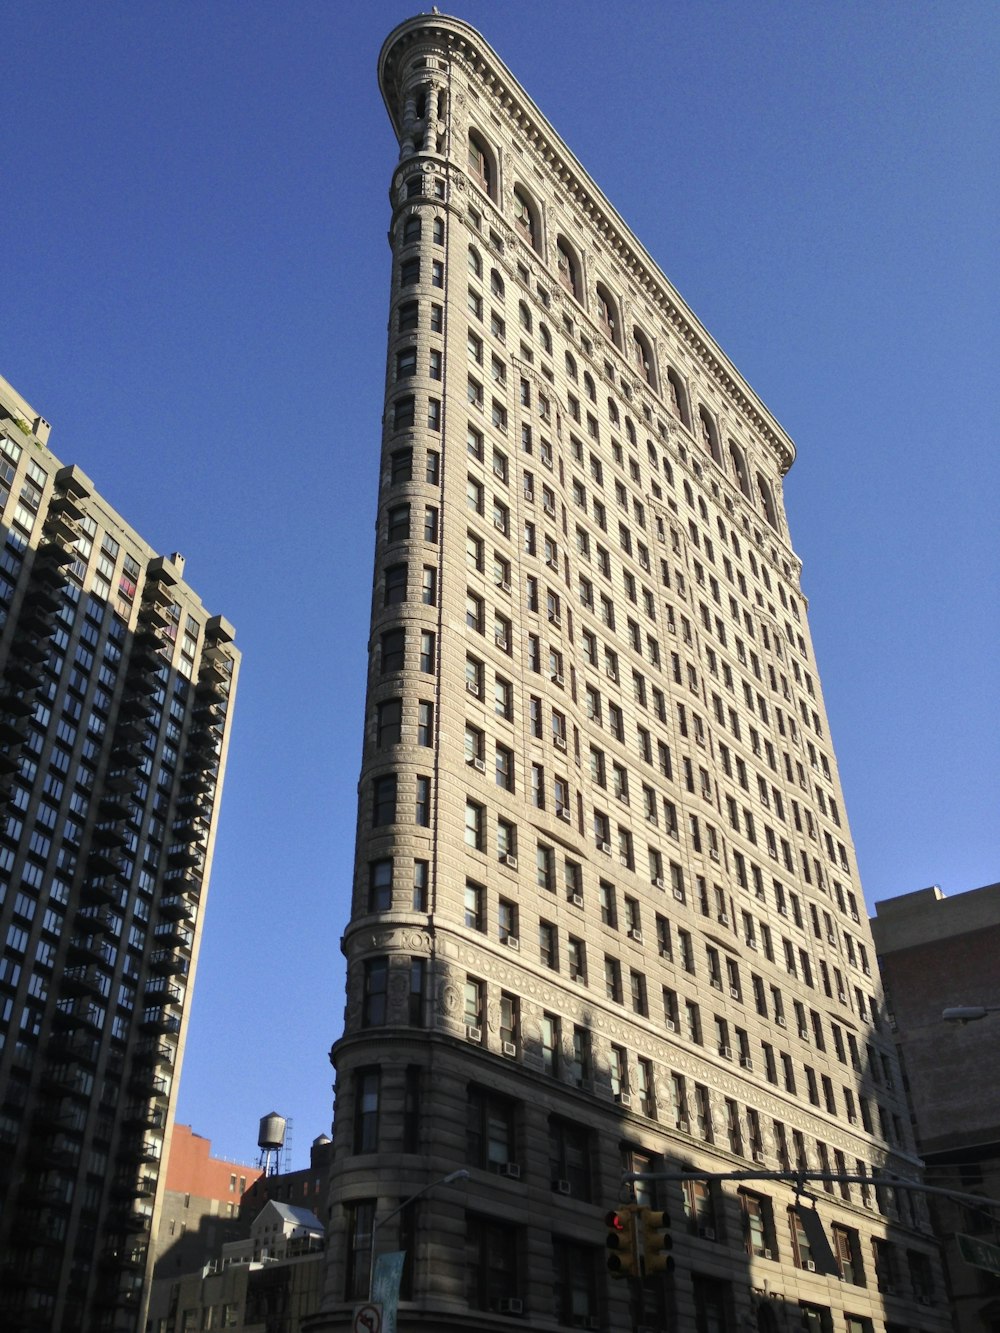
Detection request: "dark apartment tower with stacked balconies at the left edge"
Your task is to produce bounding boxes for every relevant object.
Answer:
[0,380,240,1333]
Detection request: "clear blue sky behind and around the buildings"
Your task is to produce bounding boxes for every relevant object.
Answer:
[0,0,1000,1165]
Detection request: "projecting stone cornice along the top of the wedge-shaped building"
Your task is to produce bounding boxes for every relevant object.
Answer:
[379,13,796,475]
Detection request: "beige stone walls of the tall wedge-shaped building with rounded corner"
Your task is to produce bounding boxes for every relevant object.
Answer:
[313,17,944,1329]
